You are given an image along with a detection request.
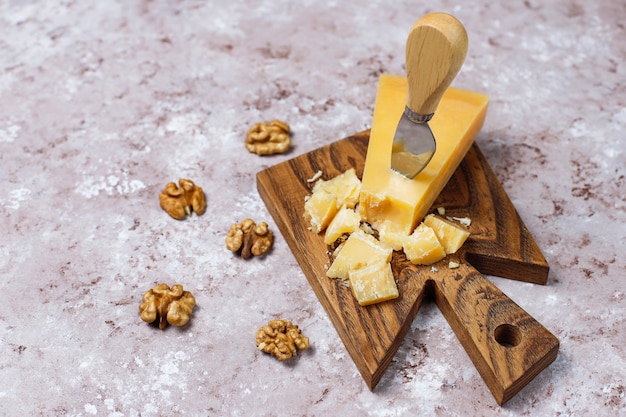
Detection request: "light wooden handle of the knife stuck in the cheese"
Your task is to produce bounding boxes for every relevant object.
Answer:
[406,12,467,115]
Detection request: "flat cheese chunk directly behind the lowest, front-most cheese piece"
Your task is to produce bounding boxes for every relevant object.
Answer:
[326,230,392,279]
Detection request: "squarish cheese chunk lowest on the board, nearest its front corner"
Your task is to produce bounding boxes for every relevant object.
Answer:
[349,261,399,306]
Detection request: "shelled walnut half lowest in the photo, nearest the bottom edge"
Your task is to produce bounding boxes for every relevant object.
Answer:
[256,320,309,361]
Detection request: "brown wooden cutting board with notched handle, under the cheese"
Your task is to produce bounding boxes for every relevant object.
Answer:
[257,131,559,404]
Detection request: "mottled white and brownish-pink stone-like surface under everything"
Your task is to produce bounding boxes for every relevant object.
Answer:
[0,0,626,416]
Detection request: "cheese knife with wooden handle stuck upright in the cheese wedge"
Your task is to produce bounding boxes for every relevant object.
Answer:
[391,12,467,178]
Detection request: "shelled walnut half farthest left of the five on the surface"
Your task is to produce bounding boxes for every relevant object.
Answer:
[139,284,196,330]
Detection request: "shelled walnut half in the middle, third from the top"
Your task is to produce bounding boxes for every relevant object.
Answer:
[226,219,274,259]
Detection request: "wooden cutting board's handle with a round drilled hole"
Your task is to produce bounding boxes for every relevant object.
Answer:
[435,264,559,405]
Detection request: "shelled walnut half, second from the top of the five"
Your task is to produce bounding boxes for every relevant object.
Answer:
[159,178,206,220]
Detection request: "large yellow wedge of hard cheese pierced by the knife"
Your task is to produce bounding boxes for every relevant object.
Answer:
[359,74,489,235]
